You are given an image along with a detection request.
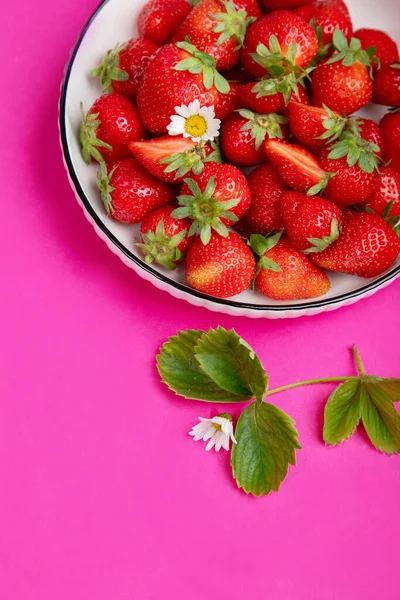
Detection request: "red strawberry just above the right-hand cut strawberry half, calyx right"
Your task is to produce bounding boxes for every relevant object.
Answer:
[286,101,346,150]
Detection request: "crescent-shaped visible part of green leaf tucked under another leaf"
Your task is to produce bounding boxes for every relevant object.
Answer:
[157,330,252,403]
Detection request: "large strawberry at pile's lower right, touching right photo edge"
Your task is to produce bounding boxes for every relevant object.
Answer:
[311,210,400,277]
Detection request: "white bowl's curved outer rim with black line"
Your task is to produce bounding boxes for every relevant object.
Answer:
[59,0,400,313]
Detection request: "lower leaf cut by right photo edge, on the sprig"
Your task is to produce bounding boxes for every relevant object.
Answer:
[361,377,400,455]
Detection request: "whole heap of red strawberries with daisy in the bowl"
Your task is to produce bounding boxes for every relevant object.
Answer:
[80,0,400,300]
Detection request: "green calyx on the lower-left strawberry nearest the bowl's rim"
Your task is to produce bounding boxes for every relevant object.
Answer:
[136,221,187,271]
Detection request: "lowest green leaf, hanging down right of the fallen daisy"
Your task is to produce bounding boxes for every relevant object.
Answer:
[231,402,301,496]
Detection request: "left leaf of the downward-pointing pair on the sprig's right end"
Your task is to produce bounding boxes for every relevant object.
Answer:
[324,379,361,446]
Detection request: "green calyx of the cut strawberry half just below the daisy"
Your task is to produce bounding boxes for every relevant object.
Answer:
[160,141,222,179]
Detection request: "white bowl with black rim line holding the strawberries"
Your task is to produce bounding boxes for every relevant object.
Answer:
[60,0,400,318]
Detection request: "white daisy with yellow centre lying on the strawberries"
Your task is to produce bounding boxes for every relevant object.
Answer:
[167,100,221,143]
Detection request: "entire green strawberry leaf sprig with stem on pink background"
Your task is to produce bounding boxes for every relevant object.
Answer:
[157,327,400,496]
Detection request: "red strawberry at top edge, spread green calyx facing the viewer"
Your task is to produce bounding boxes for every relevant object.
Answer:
[173,0,261,71]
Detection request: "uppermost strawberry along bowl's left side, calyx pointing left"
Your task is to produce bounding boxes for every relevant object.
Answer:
[91,38,157,99]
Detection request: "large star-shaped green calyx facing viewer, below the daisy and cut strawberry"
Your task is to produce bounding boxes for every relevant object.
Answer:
[171,176,240,246]
